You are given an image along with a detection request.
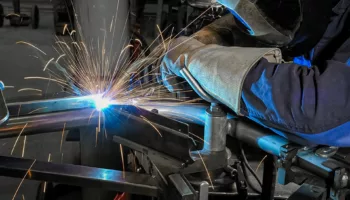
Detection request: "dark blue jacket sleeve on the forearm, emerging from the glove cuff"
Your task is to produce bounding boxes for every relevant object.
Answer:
[241,59,350,147]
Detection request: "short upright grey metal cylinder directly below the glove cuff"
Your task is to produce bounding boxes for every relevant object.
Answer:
[202,104,227,153]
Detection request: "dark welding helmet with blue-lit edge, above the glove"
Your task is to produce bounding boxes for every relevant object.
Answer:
[217,0,334,54]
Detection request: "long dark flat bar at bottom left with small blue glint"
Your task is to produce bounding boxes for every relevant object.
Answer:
[0,156,161,197]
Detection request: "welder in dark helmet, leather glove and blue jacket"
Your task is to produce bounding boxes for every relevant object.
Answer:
[160,0,350,146]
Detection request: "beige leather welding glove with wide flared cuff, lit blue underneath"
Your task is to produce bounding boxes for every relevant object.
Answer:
[160,37,282,114]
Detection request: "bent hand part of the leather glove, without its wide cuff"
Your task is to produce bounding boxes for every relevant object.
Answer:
[159,37,205,92]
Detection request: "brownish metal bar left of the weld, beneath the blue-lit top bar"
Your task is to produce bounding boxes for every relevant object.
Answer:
[0,109,99,138]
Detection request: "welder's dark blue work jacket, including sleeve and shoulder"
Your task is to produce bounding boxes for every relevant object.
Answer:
[242,0,350,147]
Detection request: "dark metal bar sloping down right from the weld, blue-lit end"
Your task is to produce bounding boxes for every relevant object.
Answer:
[105,106,194,163]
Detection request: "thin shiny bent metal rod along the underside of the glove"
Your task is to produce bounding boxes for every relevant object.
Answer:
[180,67,218,103]
